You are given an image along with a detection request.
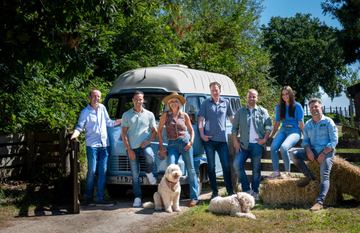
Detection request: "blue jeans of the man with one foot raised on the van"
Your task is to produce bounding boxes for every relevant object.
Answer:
[126,145,154,198]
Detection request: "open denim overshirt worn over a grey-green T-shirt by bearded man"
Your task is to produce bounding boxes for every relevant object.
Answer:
[231,105,272,150]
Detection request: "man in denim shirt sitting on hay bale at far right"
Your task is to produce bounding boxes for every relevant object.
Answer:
[290,98,338,211]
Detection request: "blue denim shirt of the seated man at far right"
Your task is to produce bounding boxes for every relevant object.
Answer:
[301,115,338,153]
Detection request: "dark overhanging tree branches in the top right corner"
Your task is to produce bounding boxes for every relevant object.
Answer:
[321,0,360,64]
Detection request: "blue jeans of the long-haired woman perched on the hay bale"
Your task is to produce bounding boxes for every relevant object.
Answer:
[270,127,301,171]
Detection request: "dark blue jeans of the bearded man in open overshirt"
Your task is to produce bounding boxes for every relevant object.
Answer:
[233,143,264,193]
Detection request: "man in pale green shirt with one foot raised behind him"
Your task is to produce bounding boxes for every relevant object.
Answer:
[121,91,157,207]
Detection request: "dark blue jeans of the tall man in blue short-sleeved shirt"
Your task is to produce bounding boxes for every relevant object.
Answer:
[203,140,234,195]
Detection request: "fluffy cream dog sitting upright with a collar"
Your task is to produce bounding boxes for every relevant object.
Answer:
[143,164,182,213]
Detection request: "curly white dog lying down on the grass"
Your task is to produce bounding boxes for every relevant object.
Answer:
[208,192,256,219]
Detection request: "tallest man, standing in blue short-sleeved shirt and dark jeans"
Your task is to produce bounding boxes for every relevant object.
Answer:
[198,82,234,198]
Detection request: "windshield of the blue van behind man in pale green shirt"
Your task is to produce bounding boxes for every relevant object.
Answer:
[105,93,168,120]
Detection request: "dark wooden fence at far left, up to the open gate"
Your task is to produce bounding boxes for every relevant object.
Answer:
[0,129,71,180]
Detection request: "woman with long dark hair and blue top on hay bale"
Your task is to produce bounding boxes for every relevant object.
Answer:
[267,86,304,179]
